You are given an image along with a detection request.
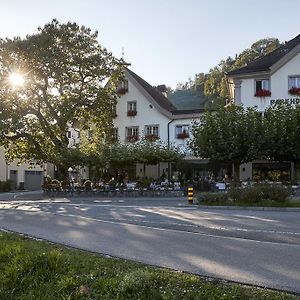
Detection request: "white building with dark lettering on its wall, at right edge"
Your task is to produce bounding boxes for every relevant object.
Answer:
[227,35,300,180]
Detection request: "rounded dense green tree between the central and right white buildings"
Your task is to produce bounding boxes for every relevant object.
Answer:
[190,105,263,180]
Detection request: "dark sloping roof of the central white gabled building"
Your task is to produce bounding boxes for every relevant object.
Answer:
[126,68,176,113]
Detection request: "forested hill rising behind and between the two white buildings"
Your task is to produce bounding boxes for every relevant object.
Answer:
[168,38,281,109]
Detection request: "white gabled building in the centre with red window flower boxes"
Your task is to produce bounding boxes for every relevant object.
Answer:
[114,68,202,178]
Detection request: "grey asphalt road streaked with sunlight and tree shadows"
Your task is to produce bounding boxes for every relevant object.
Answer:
[0,193,300,293]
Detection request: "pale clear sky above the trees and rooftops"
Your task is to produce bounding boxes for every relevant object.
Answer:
[0,0,300,88]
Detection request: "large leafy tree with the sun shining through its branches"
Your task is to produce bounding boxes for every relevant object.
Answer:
[0,20,122,178]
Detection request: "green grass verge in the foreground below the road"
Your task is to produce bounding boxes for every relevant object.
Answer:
[0,231,299,300]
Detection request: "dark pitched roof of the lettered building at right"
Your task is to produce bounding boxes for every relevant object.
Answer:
[227,34,300,76]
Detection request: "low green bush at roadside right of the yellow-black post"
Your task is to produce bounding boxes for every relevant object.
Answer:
[228,183,291,203]
